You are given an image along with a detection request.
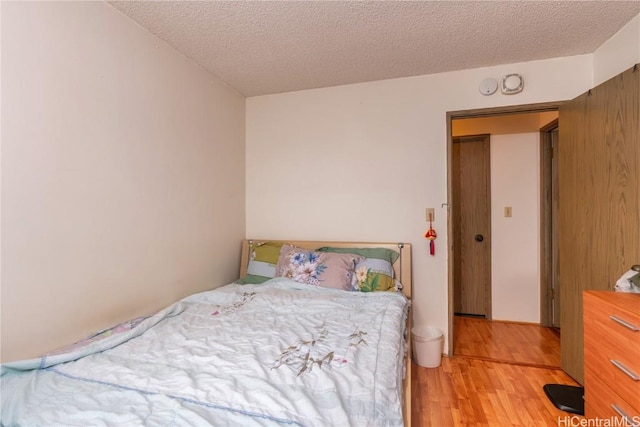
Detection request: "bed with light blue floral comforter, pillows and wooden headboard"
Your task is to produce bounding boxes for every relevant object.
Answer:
[0,240,411,426]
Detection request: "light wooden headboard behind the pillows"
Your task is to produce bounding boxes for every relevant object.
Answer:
[240,239,412,298]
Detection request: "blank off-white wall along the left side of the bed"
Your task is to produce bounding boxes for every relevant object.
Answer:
[1,2,245,361]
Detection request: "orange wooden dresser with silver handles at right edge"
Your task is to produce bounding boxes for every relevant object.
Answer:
[583,291,640,426]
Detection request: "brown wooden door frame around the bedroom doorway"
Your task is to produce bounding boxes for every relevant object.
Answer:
[443,101,564,356]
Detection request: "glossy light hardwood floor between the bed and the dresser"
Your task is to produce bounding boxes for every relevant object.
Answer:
[412,319,578,427]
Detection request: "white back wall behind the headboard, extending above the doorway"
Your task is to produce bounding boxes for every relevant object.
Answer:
[246,55,592,352]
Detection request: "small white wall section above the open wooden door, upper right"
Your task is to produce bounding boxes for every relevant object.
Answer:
[593,15,640,86]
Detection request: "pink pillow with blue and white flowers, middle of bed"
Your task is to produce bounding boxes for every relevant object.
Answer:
[276,245,364,291]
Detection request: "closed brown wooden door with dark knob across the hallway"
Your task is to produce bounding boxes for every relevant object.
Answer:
[451,135,491,319]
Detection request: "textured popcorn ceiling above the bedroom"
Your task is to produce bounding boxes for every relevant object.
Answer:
[109,0,640,96]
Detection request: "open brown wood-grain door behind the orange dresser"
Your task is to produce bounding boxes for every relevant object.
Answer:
[558,64,640,383]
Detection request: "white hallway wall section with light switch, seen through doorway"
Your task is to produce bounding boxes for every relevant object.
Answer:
[491,132,540,323]
